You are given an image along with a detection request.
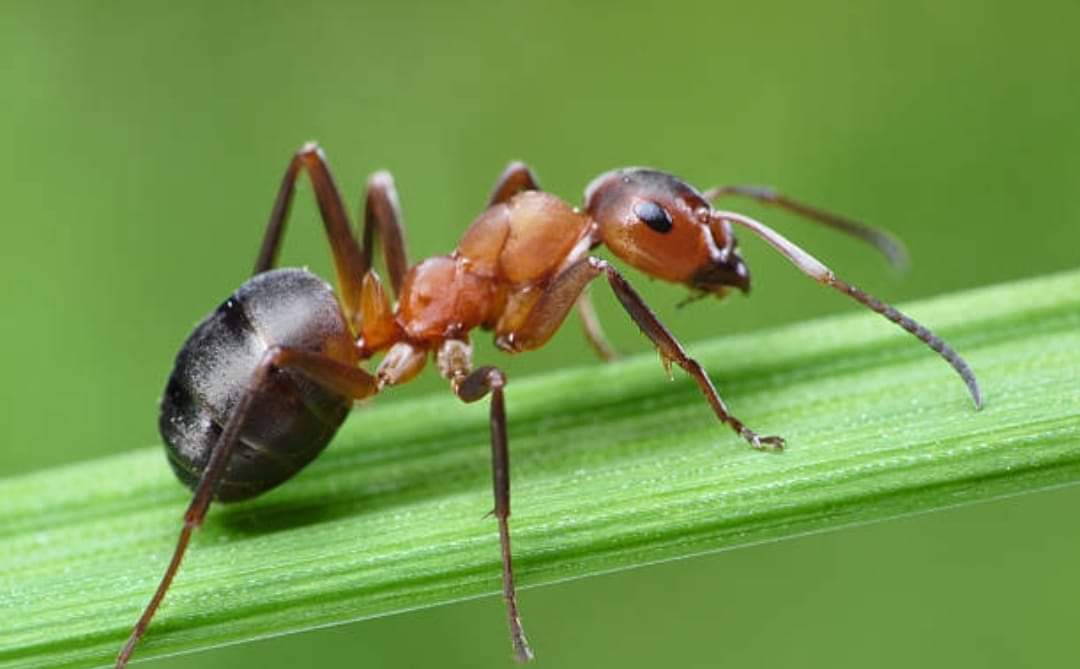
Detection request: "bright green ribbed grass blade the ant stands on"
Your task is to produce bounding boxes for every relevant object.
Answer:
[6,272,1080,667]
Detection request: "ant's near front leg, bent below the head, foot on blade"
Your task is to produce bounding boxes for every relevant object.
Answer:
[496,256,784,451]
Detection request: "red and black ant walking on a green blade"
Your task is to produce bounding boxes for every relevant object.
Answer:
[116,144,982,668]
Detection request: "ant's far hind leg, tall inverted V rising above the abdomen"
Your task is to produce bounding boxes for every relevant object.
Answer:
[255,142,368,327]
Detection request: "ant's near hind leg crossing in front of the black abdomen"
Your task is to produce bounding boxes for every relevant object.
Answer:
[116,347,378,669]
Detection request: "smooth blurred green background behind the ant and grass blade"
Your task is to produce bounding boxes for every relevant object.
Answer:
[0,0,1080,669]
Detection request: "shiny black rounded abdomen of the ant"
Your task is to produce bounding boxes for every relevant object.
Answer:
[159,269,356,501]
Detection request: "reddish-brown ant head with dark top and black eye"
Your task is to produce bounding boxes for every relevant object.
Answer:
[585,168,750,295]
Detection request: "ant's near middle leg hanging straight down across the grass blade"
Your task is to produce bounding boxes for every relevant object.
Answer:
[437,339,532,663]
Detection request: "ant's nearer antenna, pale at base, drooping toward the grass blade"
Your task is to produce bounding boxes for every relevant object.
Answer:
[713,212,983,410]
